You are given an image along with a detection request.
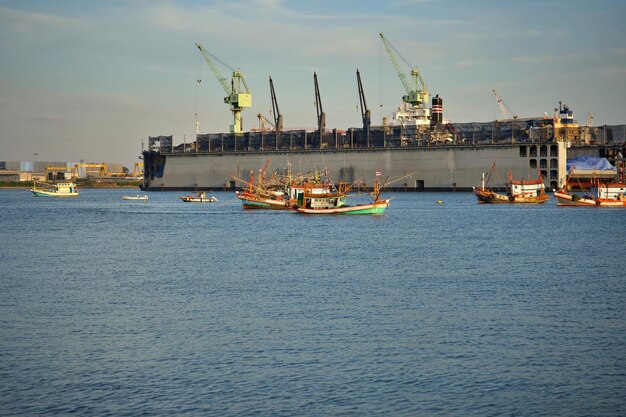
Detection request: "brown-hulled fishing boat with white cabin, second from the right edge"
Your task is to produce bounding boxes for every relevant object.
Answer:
[474,163,550,204]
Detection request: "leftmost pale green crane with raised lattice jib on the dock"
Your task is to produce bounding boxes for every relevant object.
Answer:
[196,44,252,133]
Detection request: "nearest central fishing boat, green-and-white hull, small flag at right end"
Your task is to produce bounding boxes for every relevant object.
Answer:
[297,180,391,215]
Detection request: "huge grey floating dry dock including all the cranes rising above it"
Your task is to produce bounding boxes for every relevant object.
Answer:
[142,36,626,191]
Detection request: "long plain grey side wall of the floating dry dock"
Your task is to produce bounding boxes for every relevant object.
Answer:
[143,142,567,191]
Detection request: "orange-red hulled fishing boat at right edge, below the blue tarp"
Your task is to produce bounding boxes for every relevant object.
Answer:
[554,182,626,207]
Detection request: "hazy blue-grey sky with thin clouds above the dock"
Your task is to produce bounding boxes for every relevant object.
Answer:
[0,0,626,169]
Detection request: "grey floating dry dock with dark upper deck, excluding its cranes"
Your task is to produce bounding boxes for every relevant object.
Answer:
[143,119,624,191]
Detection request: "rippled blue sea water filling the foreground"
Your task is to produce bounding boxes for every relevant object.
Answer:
[0,189,626,416]
